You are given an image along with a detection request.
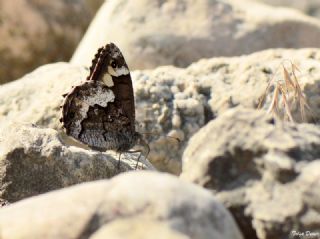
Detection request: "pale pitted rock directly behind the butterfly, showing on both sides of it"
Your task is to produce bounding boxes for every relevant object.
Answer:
[0,49,320,174]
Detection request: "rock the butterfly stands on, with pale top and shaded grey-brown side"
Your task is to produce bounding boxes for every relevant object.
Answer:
[0,124,152,204]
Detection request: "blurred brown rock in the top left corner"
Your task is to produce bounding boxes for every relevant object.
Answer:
[0,0,94,84]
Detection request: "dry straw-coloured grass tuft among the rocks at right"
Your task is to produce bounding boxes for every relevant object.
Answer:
[258,61,312,122]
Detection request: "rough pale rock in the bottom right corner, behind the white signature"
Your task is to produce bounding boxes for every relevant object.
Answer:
[247,161,320,239]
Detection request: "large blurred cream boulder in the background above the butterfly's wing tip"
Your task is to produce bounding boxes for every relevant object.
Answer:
[71,0,320,69]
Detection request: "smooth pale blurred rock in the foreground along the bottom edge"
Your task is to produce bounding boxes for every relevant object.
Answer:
[0,172,243,239]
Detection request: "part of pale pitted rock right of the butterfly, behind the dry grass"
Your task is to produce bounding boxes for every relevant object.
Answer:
[132,49,320,174]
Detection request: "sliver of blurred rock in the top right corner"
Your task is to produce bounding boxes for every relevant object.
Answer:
[257,0,320,17]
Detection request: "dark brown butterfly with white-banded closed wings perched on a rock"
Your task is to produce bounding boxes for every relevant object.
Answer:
[60,43,150,167]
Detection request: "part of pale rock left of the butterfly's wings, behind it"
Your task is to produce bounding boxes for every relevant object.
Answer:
[0,63,84,129]
